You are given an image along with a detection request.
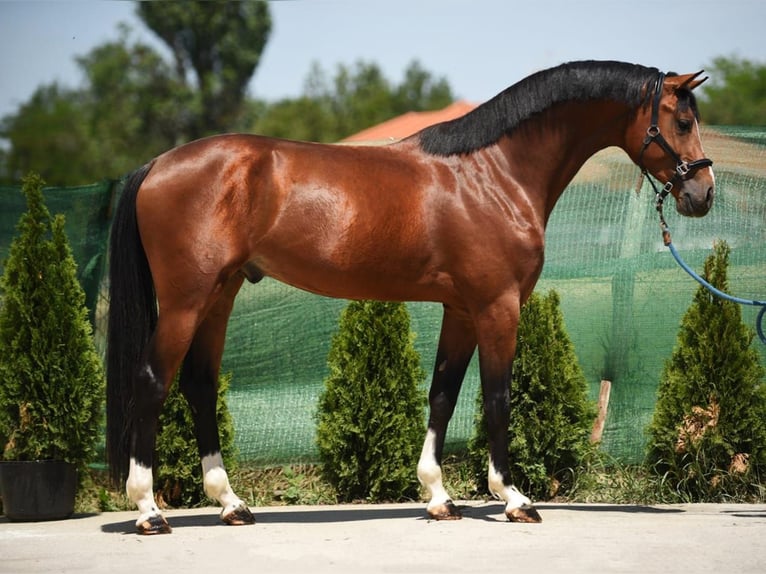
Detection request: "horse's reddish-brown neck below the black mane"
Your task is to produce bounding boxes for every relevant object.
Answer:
[499,101,630,221]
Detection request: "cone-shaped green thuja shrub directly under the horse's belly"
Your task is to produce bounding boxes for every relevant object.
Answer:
[317,301,425,501]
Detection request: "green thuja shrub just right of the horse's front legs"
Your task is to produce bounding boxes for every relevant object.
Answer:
[468,290,596,500]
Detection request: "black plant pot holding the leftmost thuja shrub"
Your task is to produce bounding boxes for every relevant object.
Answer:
[0,460,77,522]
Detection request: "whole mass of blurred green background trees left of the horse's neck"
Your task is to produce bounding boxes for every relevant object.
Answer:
[0,1,452,185]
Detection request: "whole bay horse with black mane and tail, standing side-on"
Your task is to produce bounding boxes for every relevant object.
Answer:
[107,61,714,534]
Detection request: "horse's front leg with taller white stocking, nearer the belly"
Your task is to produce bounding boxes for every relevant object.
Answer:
[418,307,476,520]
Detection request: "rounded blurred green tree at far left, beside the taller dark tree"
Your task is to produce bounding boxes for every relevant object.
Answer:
[0,27,191,185]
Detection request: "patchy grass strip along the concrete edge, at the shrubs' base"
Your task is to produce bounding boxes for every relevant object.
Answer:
[66,453,766,513]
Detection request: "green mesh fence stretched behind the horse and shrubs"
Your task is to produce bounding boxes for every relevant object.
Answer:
[0,127,766,465]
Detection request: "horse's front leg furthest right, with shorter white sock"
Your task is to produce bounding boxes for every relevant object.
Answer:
[477,298,542,522]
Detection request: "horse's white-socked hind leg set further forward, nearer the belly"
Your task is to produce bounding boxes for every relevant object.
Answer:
[180,276,255,525]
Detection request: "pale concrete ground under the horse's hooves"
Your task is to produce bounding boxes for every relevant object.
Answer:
[0,502,766,574]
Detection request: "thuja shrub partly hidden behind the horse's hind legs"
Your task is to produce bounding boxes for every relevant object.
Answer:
[155,374,237,507]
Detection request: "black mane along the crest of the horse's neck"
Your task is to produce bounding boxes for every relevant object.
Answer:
[415,61,659,156]
